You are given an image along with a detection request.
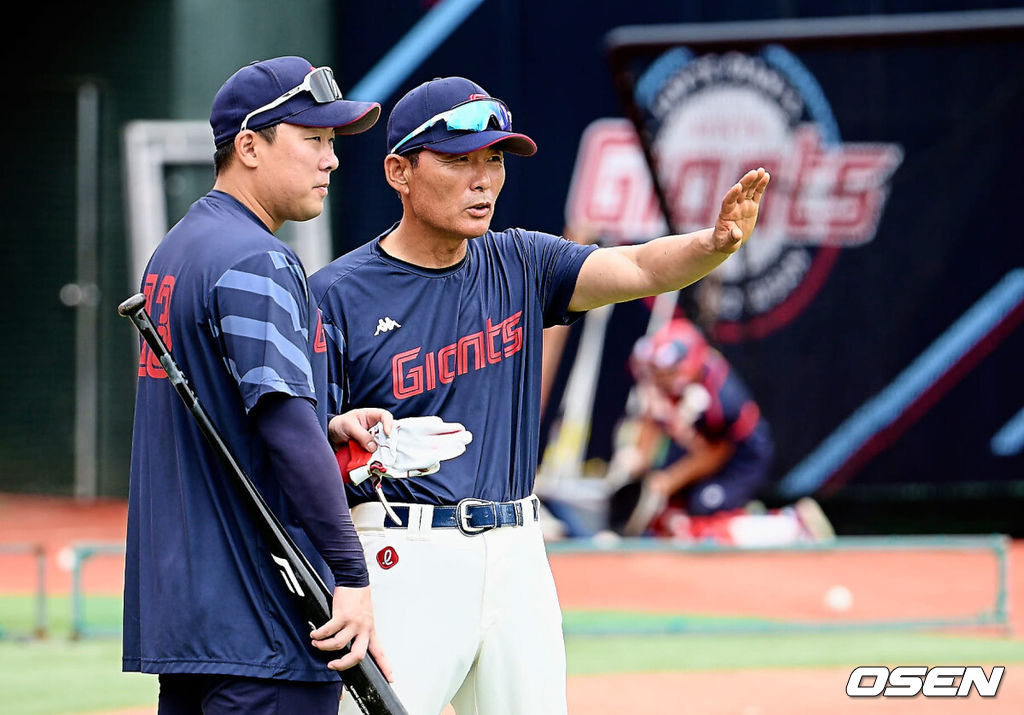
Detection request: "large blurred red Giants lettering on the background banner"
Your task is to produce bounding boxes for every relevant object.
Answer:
[568,119,903,246]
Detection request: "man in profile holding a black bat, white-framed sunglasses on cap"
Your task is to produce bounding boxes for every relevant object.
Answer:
[123,56,391,713]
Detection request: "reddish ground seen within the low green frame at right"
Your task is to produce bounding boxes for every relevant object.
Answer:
[551,546,1013,623]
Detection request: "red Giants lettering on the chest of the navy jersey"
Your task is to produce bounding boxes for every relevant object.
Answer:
[391,310,522,399]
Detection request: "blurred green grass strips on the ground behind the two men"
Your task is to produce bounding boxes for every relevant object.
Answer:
[0,597,1024,715]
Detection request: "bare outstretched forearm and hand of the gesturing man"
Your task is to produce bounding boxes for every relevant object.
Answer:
[569,169,770,311]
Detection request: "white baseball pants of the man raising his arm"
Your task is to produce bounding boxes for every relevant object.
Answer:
[340,497,566,715]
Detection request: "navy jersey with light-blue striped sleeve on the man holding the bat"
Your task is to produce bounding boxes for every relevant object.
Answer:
[123,191,337,680]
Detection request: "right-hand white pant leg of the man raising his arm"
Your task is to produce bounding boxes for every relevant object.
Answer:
[452,522,567,715]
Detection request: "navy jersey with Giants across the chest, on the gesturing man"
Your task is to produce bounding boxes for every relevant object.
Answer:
[309,228,596,504]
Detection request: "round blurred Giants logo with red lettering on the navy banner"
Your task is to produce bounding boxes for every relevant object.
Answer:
[566,47,903,342]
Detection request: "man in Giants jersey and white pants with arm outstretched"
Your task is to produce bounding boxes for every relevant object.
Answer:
[310,77,768,715]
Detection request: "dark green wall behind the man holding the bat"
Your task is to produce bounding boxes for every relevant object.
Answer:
[0,0,335,496]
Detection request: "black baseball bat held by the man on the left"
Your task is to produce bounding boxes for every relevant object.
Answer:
[118,293,408,715]
